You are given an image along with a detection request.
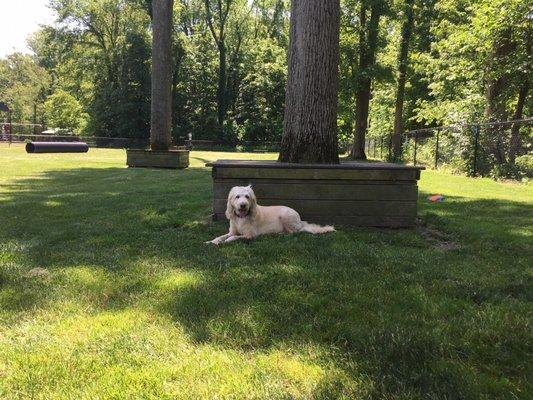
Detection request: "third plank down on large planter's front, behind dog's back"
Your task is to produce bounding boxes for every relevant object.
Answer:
[213,199,416,218]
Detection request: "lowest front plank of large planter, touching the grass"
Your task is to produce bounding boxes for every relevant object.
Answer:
[213,213,415,228]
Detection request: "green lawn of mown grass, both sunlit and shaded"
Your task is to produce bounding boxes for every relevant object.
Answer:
[0,145,533,399]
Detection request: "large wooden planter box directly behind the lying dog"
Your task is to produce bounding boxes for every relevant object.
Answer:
[207,160,424,228]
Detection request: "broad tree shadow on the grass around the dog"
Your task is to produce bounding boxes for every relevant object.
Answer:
[0,168,532,398]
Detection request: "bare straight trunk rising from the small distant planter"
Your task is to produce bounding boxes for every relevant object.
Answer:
[150,0,173,150]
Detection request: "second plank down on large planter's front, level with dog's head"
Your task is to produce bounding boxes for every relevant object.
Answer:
[213,181,418,201]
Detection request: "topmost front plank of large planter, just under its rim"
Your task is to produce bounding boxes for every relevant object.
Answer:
[213,167,419,181]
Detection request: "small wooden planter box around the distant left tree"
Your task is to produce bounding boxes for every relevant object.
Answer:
[126,149,189,169]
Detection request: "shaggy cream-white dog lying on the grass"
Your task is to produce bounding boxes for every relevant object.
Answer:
[206,185,335,244]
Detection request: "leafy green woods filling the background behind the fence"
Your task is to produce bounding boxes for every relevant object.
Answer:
[0,0,532,173]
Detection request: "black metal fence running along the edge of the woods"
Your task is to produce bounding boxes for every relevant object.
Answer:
[6,118,533,176]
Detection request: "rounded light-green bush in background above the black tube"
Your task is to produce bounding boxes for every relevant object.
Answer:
[44,90,86,133]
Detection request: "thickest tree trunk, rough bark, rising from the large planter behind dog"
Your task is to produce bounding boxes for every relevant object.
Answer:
[279,0,340,164]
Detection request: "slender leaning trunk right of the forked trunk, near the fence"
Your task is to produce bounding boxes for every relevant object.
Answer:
[392,0,414,161]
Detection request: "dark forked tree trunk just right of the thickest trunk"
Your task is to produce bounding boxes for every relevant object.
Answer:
[351,1,383,160]
